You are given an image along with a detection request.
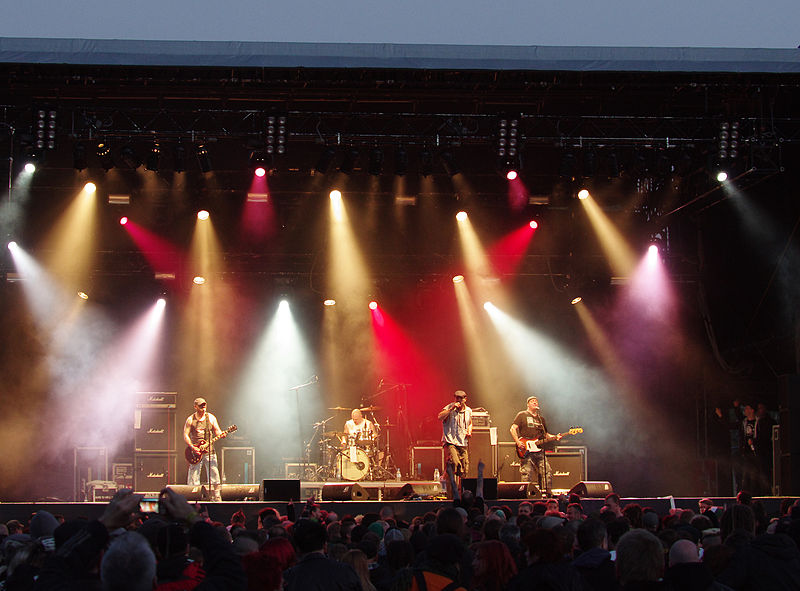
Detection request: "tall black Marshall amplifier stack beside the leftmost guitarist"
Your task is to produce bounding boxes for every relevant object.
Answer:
[133,392,178,492]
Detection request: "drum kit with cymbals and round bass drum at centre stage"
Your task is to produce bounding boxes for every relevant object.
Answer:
[315,406,397,481]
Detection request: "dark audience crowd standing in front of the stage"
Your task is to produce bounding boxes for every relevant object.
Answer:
[0,489,800,591]
